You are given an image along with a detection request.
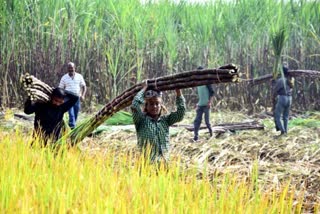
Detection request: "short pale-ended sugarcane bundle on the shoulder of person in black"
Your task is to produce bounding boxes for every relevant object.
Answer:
[21,73,53,102]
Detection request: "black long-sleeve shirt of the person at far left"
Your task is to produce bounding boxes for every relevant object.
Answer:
[24,92,79,141]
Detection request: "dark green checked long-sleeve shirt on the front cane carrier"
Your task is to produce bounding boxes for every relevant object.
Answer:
[131,90,186,162]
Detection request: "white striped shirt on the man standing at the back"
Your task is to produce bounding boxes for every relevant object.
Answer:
[59,73,86,96]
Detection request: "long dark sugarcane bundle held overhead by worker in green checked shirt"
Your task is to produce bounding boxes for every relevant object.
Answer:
[58,64,239,144]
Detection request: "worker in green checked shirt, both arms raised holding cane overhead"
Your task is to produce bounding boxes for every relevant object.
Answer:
[131,81,186,164]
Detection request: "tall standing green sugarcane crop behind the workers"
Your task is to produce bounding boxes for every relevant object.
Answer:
[0,0,320,109]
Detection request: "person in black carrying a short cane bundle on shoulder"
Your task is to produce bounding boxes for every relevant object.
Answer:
[24,88,79,145]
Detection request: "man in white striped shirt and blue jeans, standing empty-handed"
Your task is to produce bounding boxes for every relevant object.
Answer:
[59,62,87,129]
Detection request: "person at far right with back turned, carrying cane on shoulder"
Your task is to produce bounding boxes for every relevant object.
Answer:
[273,66,294,136]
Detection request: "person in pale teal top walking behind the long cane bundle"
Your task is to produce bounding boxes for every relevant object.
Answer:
[193,66,214,142]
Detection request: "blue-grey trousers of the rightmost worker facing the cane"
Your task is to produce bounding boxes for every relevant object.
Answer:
[274,95,292,134]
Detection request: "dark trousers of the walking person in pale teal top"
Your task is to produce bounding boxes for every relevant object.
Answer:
[193,106,212,140]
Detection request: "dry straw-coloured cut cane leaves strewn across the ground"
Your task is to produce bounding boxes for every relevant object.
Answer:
[80,112,320,211]
